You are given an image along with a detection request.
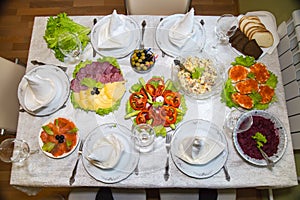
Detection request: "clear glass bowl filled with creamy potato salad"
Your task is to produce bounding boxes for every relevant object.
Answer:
[171,52,224,100]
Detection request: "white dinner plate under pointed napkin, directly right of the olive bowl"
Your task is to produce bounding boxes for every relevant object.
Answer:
[155,14,205,57]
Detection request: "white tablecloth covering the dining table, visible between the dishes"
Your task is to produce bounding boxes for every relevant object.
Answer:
[10,12,298,195]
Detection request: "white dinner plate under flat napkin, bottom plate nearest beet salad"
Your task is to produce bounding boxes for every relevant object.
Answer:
[171,119,228,178]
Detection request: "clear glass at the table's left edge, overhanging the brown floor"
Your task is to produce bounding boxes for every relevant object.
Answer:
[0,138,30,163]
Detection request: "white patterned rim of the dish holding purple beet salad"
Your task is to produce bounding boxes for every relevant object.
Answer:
[232,110,287,166]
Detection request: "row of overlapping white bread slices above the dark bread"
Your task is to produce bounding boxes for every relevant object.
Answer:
[239,15,274,48]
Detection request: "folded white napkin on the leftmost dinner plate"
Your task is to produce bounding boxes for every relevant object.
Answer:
[24,74,56,111]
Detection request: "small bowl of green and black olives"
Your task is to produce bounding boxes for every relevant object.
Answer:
[130,49,156,74]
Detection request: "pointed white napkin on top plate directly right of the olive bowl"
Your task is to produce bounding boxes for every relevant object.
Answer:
[169,8,195,48]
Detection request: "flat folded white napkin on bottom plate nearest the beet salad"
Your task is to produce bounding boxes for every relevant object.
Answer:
[175,136,225,165]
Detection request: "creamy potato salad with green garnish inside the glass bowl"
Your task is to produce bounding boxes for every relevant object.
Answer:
[178,56,217,95]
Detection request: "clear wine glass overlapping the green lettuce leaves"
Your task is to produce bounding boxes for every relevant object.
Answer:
[57,32,82,61]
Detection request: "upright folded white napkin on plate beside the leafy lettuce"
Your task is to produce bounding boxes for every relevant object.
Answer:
[97,10,130,49]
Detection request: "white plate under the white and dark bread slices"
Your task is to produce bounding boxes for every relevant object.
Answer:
[232,11,279,58]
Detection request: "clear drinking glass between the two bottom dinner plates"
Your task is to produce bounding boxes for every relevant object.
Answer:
[132,124,155,152]
